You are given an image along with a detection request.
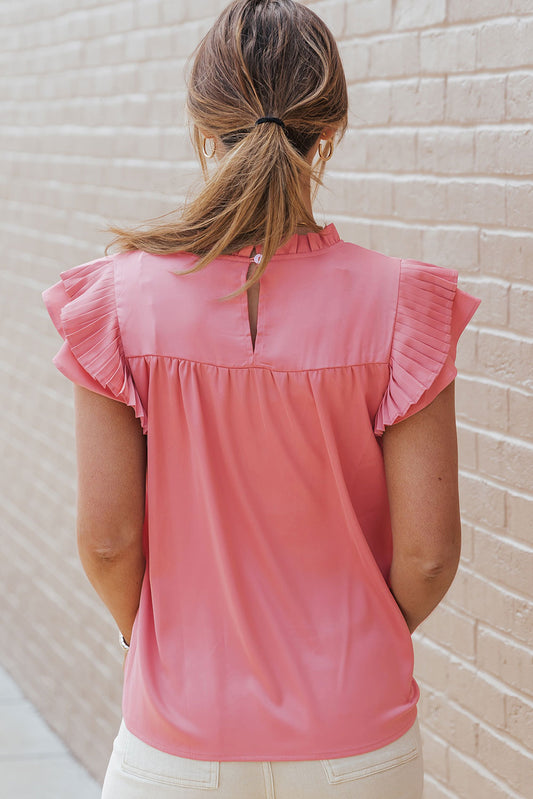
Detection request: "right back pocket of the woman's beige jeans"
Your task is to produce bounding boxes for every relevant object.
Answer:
[320,719,422,785]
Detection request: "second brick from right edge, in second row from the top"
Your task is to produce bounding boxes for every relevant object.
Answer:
[420,28,478,75]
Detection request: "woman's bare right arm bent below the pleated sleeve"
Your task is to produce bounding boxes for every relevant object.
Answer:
[383,382,461,633]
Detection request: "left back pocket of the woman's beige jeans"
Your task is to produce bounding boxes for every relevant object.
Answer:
[121,731,220,790]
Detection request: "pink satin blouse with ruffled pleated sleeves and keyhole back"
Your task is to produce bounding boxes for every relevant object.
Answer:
[43,224,480,761]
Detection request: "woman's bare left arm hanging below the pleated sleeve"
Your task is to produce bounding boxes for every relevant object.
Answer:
[74,385,146,642]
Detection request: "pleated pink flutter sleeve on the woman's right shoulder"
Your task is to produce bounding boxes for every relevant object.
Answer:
[374,259,481,436]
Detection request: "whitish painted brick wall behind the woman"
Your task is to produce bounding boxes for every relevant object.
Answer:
[0,0,533,799]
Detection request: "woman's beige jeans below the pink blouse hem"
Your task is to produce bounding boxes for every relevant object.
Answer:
[102,718,424,799]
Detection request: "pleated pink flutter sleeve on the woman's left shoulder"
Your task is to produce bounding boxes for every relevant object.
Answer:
[42,256,147,433]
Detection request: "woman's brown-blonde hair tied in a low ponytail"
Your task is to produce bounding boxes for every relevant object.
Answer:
[106,0,348,299]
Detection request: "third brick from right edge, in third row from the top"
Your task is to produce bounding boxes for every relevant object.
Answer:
[391,78,445,125]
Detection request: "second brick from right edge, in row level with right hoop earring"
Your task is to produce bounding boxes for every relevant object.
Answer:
[417,128,474,175]
